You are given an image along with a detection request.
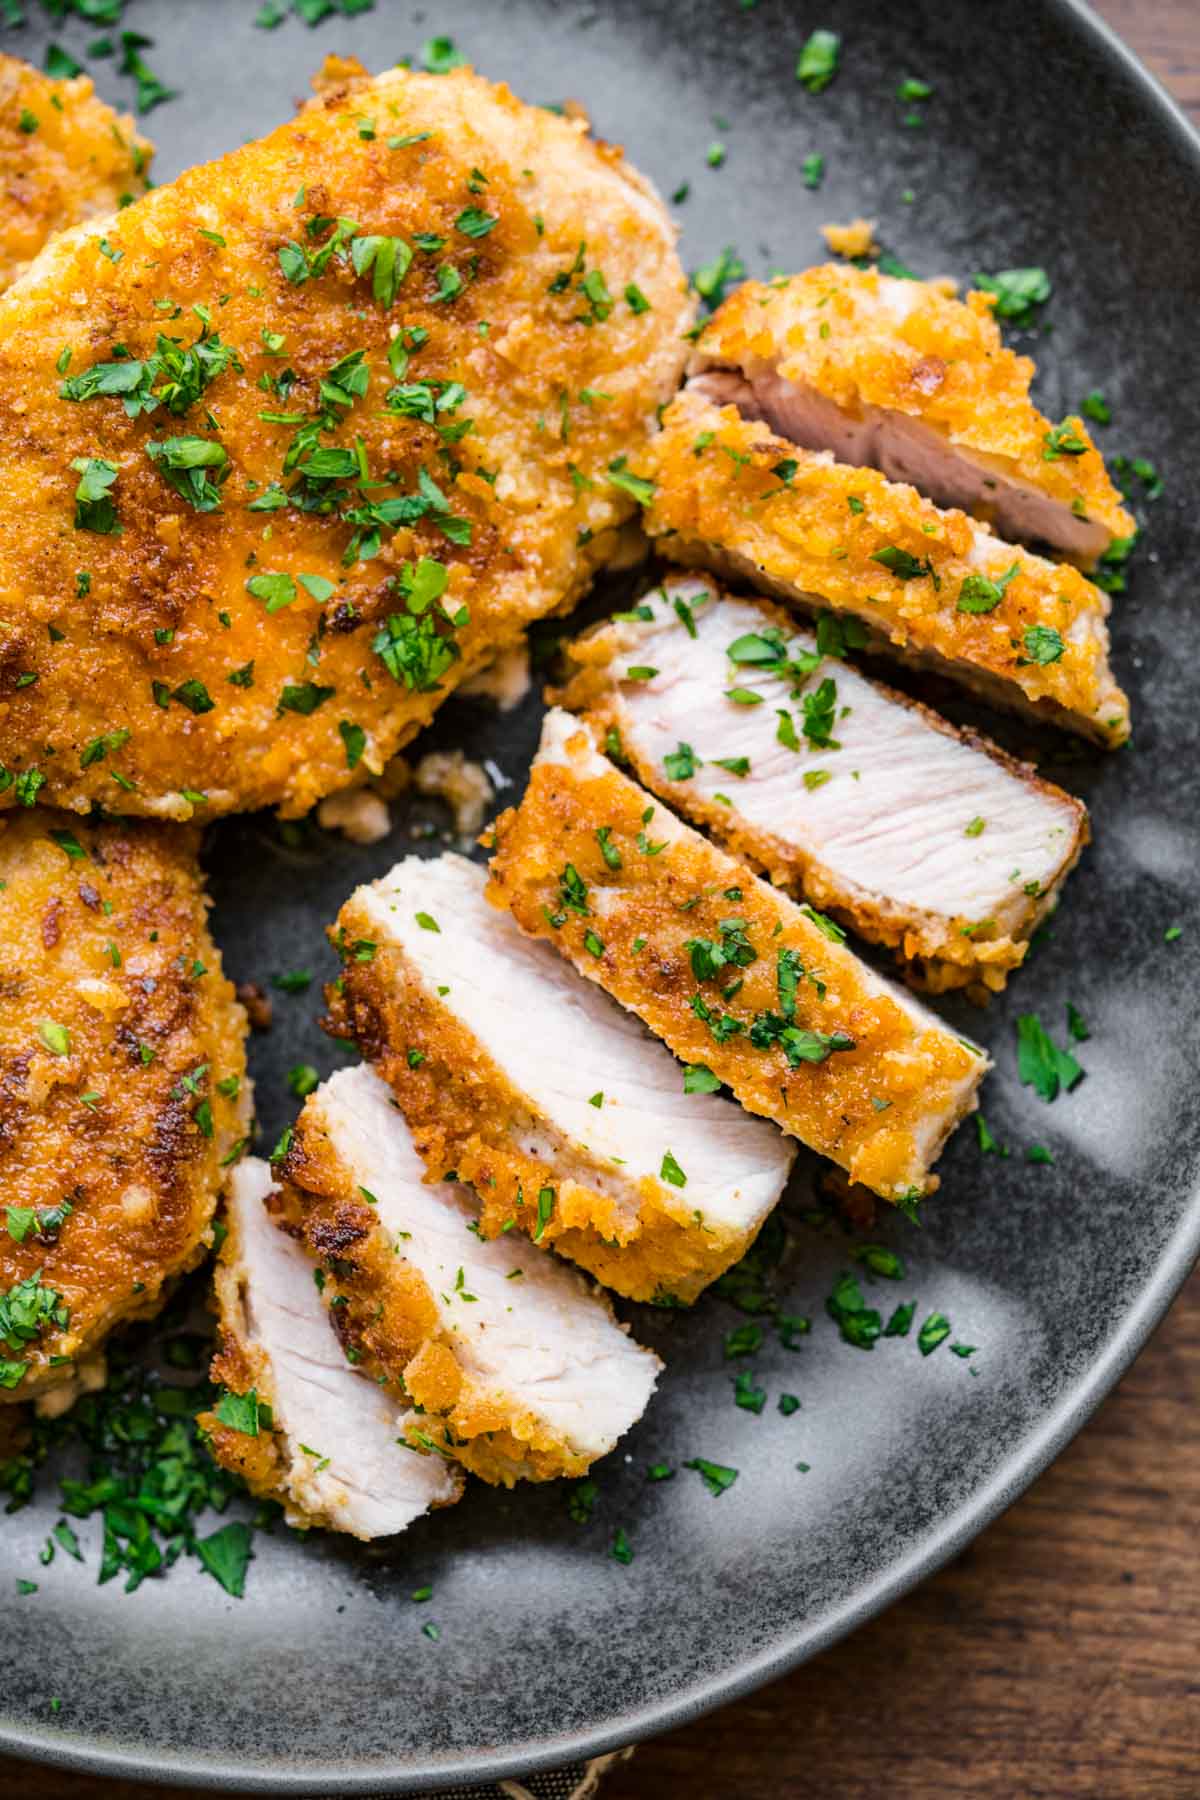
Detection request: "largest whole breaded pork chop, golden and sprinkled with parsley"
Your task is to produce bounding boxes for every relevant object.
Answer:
[0,68,691,817]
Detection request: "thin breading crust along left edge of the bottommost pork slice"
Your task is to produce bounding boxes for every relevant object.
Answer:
[196,1173,459,1535]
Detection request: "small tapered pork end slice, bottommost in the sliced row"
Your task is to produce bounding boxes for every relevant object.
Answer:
[200,1157,462,1537]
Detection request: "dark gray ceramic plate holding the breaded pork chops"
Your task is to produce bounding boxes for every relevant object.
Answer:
[0,0,1200,1795]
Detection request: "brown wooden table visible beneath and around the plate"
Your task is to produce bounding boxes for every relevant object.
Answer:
[0,0,1200,1800]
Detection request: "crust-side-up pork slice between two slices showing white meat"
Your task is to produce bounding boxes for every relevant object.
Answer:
[488,711,988,1206]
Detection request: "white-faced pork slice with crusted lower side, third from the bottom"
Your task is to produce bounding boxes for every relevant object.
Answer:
[329,857,795,1301]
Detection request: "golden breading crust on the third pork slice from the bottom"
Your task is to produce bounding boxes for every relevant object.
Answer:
[326,898,770,1301]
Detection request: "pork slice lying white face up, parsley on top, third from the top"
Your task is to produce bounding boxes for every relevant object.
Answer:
[563,576,1088,995]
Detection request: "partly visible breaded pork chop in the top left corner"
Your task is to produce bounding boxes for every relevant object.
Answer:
[0,56,155,292]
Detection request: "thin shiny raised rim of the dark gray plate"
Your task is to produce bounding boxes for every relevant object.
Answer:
[0,0,1200,1800]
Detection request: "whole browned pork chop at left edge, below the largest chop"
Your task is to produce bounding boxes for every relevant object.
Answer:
[0,806,248,1400]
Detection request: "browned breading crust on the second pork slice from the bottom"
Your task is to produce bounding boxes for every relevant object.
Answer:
[277,1094,647,1487]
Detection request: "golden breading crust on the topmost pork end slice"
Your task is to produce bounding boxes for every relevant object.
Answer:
[694,263,1137,554]
